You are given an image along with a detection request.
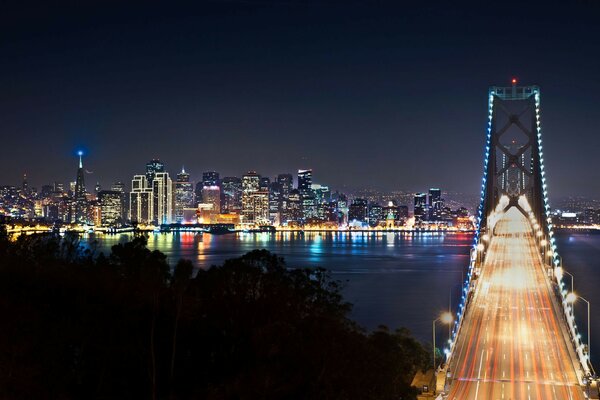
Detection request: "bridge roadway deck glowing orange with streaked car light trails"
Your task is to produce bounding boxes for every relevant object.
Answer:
[447,207,585,400]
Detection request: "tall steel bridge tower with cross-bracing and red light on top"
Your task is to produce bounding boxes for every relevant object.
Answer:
[478,79,549,233]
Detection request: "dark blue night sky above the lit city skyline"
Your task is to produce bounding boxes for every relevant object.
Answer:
[0,0,600,197]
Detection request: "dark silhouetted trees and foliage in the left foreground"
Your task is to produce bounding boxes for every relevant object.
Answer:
[0,231,428,399]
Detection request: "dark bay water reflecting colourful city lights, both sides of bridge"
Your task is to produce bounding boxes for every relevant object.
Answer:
[82,233,600,368]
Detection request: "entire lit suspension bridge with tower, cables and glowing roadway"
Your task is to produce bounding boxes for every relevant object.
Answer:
[437,80,596,400]
